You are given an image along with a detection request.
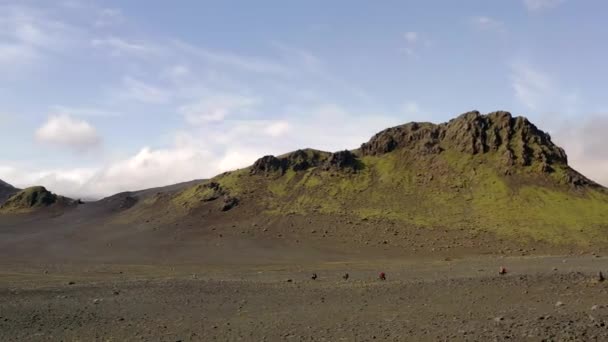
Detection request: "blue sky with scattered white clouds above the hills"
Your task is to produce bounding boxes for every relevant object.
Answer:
[0,0,608,198]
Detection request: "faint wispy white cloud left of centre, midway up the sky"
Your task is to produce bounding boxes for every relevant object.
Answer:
[179,95,259,125]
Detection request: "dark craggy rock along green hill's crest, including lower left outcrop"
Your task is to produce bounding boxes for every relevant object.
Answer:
[245,111,599,187]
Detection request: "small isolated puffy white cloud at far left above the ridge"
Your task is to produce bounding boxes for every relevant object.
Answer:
[36,114,101,151]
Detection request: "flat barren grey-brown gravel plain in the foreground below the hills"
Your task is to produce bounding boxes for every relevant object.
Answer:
[0,256,608,341]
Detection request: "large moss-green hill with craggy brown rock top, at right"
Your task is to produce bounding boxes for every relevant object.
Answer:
[171,112,608,245]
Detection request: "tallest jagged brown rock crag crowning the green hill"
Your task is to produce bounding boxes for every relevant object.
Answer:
[361,111,567,171]
